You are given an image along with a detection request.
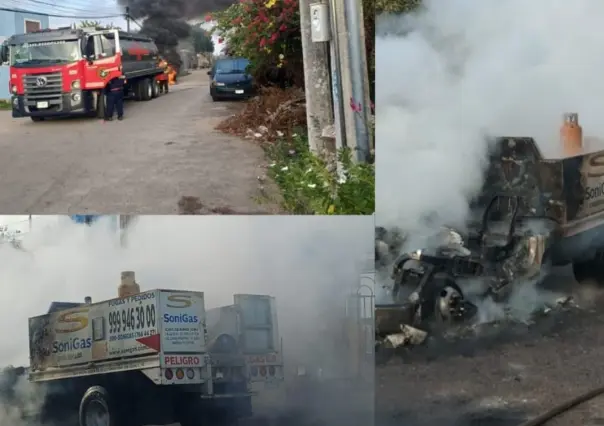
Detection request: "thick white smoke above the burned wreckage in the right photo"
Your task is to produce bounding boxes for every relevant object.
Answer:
[376,0,604,230]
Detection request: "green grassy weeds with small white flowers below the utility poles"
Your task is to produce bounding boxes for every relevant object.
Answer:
[264,132,375,215]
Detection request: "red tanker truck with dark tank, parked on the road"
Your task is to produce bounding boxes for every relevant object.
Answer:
[0,28,161,121]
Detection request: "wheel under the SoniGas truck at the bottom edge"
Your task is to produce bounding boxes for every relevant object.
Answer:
[79,386,124,426]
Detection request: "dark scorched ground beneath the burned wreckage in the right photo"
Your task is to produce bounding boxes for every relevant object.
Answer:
[375,272,604,426]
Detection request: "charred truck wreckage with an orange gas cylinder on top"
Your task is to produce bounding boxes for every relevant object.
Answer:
[376,114,604,352]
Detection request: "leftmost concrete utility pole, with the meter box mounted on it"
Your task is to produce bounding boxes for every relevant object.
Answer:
[299,0,333,154]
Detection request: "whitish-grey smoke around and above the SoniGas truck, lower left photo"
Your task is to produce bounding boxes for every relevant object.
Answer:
[0,216,374,424]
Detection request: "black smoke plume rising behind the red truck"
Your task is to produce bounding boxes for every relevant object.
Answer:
[118,0,236,67]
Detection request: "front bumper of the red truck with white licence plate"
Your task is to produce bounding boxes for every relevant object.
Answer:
[11,92,91,118]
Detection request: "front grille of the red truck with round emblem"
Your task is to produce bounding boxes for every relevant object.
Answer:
[23,72,63,111]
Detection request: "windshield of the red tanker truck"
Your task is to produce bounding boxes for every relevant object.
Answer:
[10,40,82,67]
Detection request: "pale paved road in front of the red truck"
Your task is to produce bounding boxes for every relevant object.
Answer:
[0,71,274,214]
